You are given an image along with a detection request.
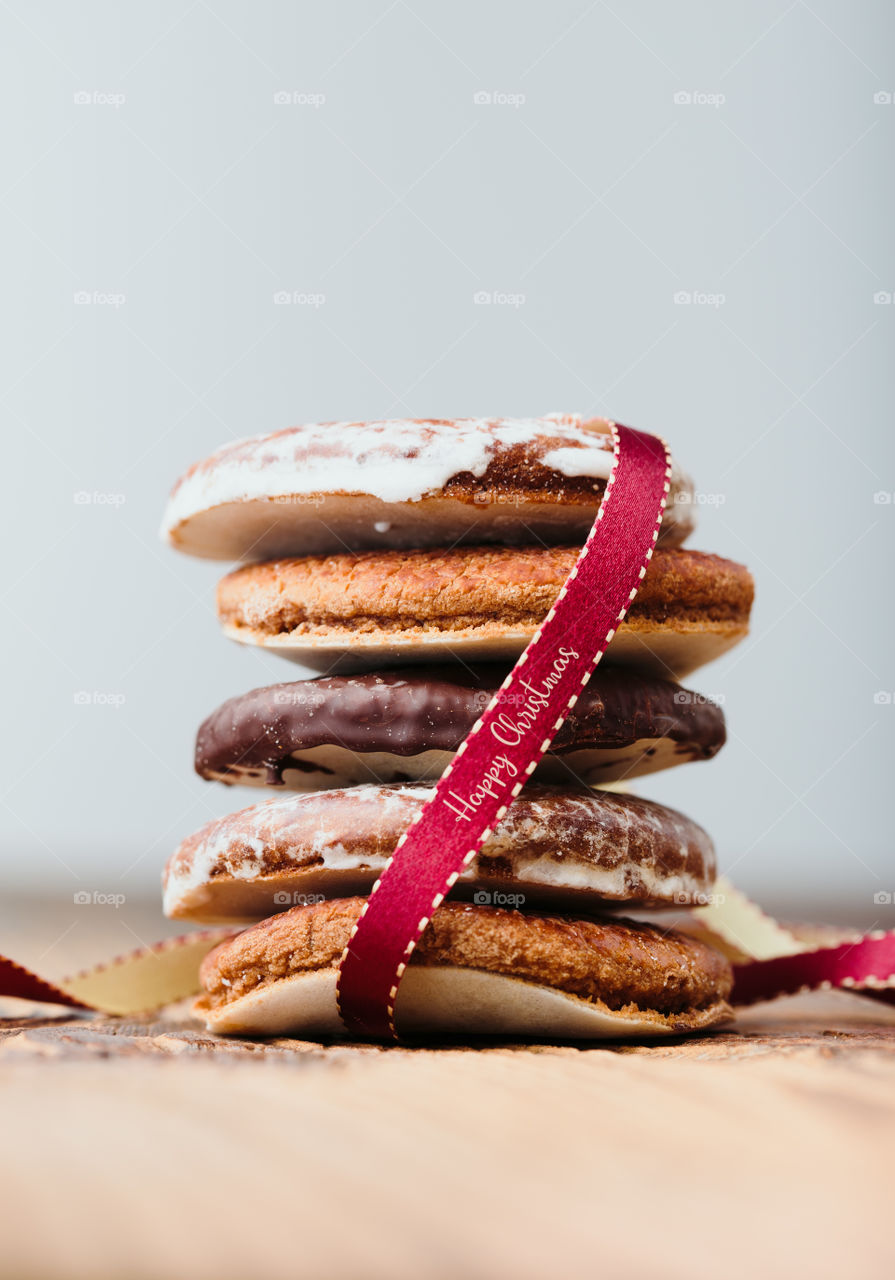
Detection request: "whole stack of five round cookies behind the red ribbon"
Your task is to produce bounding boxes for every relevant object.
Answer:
[164,415,753,1038]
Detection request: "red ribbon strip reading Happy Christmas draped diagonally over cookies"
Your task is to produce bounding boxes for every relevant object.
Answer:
[338,426,671,1039]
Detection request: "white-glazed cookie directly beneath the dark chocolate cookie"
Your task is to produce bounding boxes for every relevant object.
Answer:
[164,783,714,923]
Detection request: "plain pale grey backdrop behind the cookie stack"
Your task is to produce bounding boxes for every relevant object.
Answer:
[0,0,895,947]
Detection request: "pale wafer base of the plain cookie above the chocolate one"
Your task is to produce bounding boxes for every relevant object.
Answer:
[223,621,749,680]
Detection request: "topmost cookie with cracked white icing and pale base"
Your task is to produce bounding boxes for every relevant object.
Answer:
[161,413,695,561]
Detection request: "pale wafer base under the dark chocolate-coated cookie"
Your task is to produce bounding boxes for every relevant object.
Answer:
[207,737,693,791]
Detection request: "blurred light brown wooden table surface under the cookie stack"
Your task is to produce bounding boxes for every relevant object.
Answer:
[0,993,895,1280]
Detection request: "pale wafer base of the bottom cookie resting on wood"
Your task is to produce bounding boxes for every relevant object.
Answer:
[197,965,731,1041]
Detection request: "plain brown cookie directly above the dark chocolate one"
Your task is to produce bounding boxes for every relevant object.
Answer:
[218,547,753,678]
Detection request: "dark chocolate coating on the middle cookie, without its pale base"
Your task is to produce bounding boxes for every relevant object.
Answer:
[196,663,726,786]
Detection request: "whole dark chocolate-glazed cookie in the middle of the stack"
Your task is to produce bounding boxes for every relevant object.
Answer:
[196,664,725,791]
